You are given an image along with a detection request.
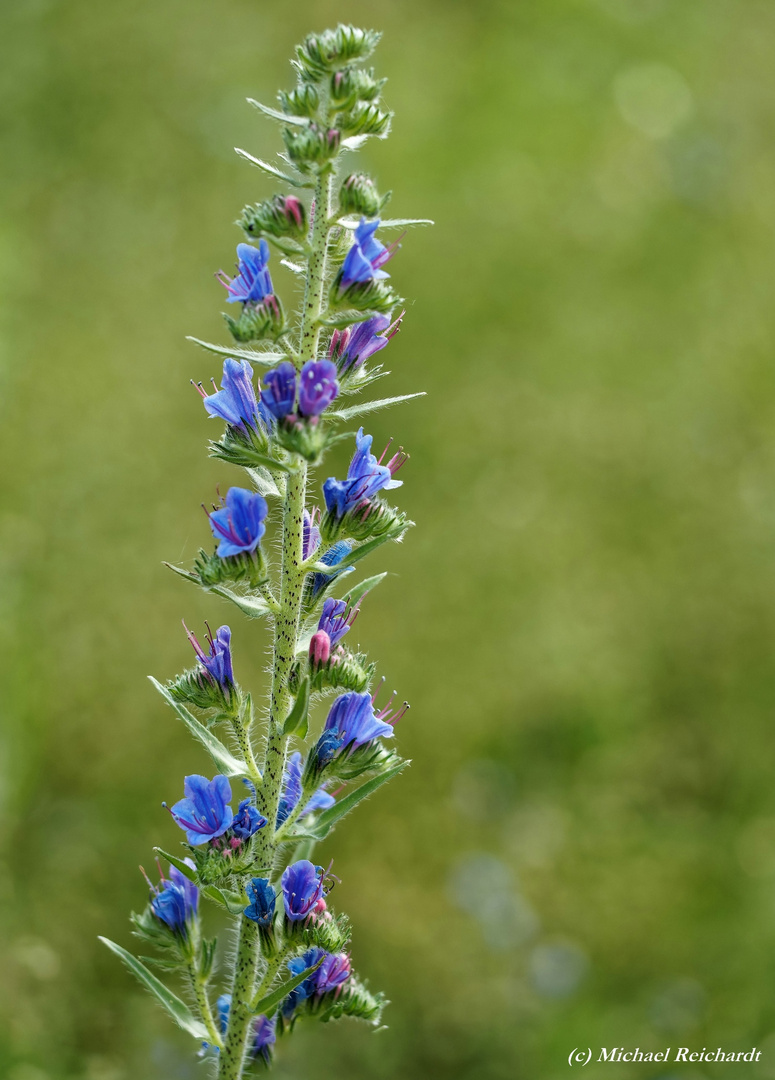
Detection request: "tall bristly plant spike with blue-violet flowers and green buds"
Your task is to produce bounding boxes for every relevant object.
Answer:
[103,26,431,1080]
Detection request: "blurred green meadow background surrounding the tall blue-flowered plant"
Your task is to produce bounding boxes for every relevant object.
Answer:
[0,0,775,1080]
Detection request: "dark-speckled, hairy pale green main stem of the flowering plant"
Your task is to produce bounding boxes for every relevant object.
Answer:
[218,159,334,1080]
